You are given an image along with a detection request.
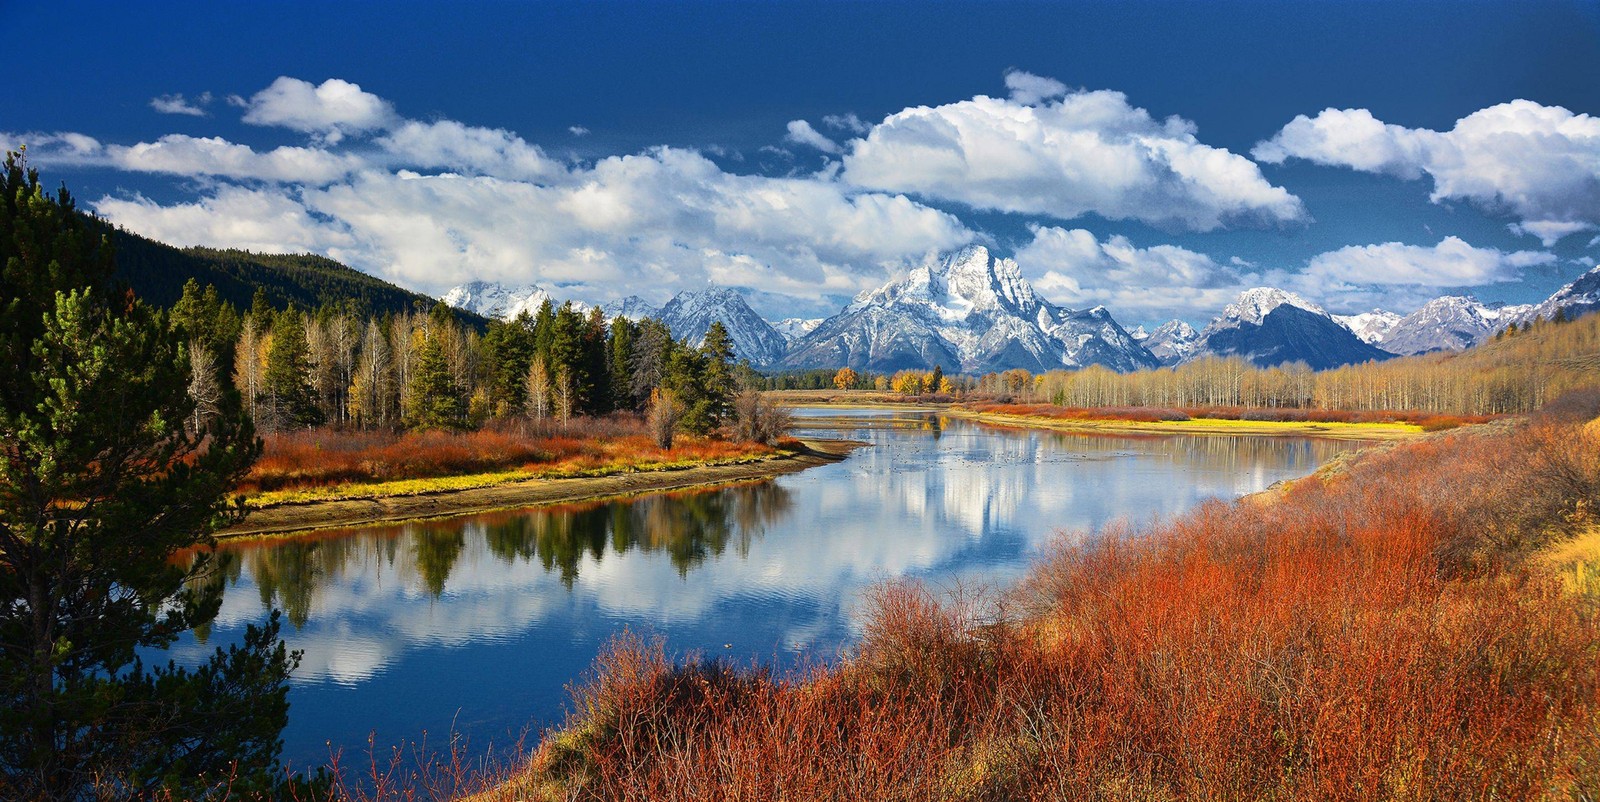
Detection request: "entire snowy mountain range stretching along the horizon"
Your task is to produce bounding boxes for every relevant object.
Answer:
[445,259,1600,373]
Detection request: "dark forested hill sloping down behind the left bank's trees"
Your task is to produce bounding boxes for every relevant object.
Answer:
[101,219,486,321]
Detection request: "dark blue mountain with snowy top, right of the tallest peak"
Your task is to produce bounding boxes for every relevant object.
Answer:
[1189,287,1394,370]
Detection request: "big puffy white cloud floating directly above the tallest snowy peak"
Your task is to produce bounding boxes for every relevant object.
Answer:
[843,79,1306,231]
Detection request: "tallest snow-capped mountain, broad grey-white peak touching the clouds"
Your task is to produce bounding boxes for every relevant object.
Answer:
[782,245,1157,373]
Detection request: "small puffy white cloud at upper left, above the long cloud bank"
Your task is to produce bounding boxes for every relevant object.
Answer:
[243,75,397,144]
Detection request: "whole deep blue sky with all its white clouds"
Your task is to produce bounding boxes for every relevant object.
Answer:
[0,2,1600,325]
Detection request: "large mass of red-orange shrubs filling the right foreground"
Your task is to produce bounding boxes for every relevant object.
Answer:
[508,399,1600,800]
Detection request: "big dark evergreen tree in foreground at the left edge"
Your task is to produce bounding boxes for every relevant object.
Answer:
[0,155,312,799]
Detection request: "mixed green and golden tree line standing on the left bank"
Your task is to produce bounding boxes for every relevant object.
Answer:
[173,282,760,443]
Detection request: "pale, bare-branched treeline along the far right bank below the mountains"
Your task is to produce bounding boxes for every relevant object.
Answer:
[974,315,1600,415]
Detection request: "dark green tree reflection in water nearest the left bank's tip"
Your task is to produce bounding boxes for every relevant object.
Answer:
[485,482,792,587]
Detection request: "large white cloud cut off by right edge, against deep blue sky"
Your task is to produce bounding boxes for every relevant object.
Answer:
[1253,99,1600,247]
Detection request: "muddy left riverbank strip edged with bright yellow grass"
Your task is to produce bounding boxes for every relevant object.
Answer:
[216,440,864,538]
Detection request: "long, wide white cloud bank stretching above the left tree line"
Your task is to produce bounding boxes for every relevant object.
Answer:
[96,147,971,301]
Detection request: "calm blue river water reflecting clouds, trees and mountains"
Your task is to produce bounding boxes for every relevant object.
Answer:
[179,410,1358,764]
